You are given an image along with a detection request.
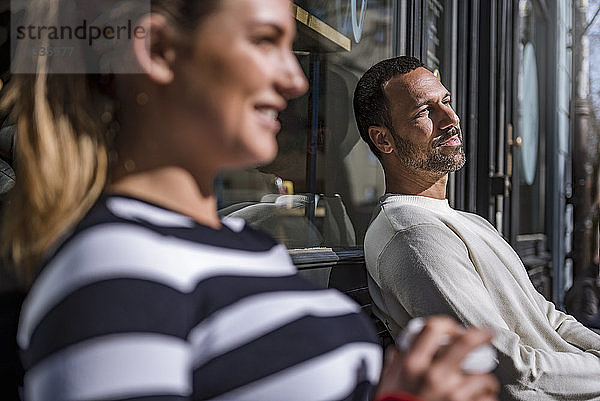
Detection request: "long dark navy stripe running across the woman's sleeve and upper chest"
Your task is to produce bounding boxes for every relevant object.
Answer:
[23,275,324,368]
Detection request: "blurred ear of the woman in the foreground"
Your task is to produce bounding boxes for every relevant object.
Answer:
[133,13,176,85]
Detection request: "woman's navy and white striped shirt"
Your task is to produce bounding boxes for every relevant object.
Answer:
[18,196,382,401]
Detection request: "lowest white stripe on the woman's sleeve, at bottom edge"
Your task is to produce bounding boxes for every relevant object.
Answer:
[24,334,192,401]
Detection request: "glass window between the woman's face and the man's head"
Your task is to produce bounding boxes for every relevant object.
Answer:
[217,0,396,248]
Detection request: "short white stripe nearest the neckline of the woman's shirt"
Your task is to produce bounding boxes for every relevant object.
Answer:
[106,198,194,228]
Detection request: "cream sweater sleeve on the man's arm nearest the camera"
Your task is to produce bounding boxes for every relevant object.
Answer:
[375,223,600,400]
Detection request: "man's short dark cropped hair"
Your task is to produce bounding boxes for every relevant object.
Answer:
[354,56,424,157]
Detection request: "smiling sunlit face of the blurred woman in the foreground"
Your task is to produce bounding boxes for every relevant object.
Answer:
[170,0,307,168]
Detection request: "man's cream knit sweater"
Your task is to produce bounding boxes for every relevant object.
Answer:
[365,195,600,401]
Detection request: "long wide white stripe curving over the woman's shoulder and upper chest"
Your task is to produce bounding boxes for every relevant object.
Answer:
[17,224,296,349]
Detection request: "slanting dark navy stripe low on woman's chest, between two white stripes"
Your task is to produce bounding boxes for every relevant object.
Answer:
[194,314,377,398]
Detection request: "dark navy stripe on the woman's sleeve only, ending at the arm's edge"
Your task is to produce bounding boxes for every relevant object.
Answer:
[22,279,188,369]
